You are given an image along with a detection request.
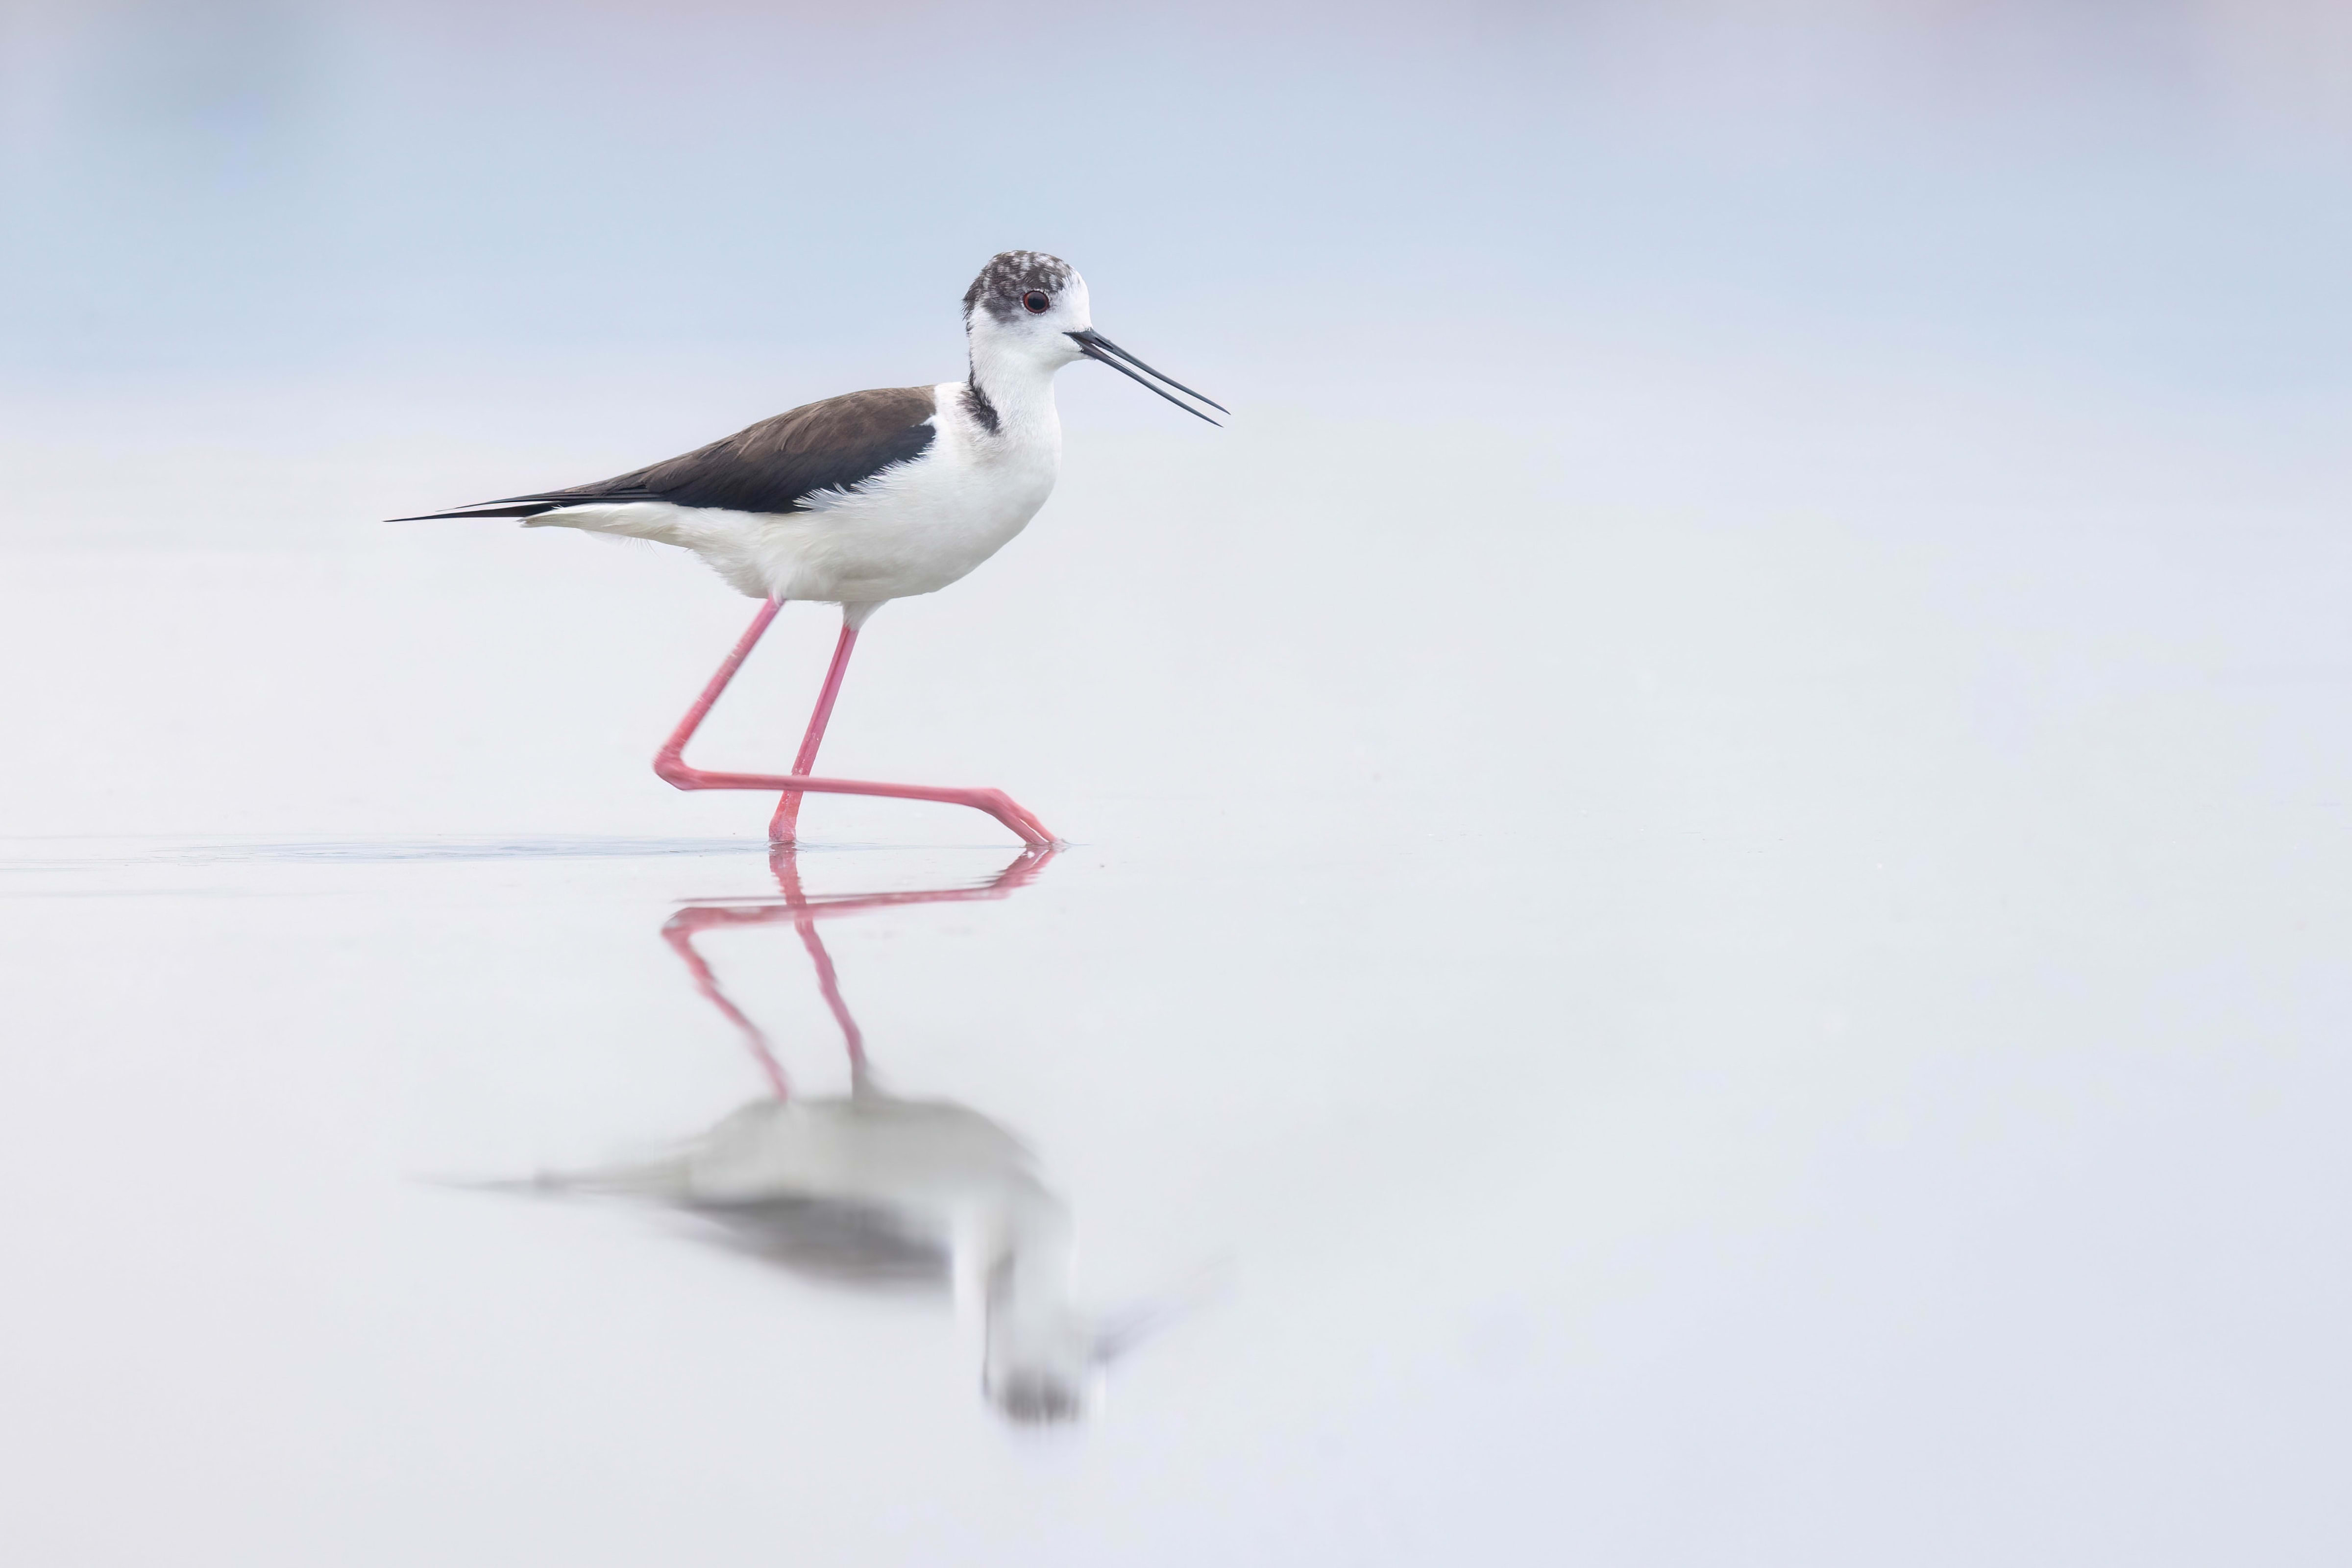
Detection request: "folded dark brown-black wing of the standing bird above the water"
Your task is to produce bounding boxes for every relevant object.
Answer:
[393,386,934,522]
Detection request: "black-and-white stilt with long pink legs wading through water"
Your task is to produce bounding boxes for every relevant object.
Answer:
[395,251,1228,844]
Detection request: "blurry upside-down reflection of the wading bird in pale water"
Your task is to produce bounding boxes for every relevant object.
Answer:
[494,846,1164,1424]
